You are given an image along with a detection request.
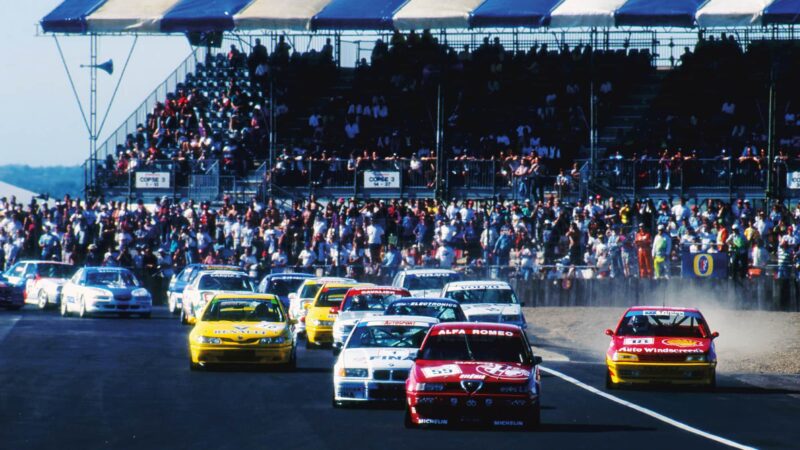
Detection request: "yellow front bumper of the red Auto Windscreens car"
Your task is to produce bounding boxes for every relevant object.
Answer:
[606,360,717,385]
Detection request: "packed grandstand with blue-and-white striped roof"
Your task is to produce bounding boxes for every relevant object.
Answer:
[41,0,800,200]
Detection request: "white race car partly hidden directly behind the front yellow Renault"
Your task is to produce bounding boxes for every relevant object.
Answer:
[181,270,255,325]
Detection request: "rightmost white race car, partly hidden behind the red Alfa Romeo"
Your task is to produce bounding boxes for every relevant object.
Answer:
[441,280,528,328]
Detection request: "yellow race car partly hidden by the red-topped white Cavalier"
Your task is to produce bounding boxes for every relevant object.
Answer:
[305,283,372,348]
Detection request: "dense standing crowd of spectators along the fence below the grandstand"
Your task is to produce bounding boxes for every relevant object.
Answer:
[0,192,800,286]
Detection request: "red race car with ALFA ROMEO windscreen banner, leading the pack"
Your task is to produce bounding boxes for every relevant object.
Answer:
[405,322,542,428]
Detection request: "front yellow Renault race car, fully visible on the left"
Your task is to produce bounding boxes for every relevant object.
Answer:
[189,294,297,370]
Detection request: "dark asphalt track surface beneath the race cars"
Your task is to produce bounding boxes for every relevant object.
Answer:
[0,306,800,450]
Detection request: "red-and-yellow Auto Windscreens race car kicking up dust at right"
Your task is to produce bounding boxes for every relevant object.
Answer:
[606,306,719,389]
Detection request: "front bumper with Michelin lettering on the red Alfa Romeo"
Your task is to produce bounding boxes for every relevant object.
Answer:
[407,392,539,427]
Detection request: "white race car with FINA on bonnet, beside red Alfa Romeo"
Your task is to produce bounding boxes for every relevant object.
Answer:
[333,316,439,407]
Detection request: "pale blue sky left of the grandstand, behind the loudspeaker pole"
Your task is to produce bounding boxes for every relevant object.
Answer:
[0,0,191,166]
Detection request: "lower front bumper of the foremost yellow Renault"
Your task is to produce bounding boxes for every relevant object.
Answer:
[190,343,294,365]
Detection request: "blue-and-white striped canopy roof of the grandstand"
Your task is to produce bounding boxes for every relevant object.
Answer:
[41,0,800,33]
